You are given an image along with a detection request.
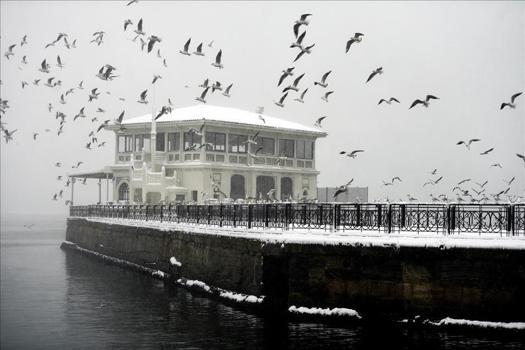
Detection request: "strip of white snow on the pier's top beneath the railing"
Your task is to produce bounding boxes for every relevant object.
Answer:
[74,218,525,250]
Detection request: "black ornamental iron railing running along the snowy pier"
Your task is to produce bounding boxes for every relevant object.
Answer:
[70,203,525,236]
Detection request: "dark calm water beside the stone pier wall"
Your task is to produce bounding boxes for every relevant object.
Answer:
[0,217,525,349]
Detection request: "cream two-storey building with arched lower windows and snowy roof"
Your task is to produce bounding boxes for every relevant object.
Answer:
[107,105,326,203]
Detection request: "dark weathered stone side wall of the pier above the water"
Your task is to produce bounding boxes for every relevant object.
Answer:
[66,218,525,321]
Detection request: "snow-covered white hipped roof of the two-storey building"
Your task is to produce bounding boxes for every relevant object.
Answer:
[122,104,326,136]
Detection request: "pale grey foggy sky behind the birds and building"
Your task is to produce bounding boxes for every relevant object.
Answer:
[0,0,525,214]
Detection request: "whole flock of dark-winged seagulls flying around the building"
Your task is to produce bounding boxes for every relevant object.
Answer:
[0,0,525,205]
